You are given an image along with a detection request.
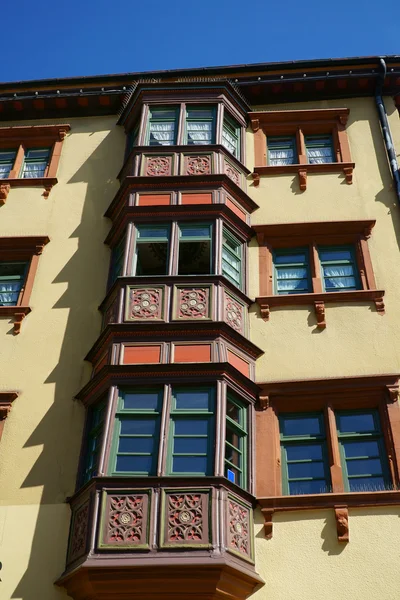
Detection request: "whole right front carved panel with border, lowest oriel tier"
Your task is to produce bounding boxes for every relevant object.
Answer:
[160,490,210,547]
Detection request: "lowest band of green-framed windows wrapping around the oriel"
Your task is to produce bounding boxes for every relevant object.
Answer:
[81,384,249,489]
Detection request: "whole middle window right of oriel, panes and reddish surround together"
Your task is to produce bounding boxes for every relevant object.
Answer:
[254,221,384,328]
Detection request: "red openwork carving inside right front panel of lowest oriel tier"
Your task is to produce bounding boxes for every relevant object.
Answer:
[168,494,203,544]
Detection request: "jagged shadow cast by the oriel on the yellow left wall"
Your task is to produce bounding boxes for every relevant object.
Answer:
[12,121,124,600]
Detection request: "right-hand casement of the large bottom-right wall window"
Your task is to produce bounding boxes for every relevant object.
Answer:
[336,410,390,492]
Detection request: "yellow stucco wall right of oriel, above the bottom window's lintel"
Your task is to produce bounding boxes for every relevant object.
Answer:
[247,98,400,382]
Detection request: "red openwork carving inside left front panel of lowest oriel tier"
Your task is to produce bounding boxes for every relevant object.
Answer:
[106,494,145,544]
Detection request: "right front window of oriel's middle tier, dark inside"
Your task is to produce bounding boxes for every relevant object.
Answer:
[178,223,212,275]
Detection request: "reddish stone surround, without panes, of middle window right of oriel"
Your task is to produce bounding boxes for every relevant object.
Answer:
[254,220,385,329]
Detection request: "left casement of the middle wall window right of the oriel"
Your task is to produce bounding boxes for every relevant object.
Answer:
[274,248,311,294]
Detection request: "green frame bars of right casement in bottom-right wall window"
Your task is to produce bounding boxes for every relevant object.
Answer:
[335,409,391,492]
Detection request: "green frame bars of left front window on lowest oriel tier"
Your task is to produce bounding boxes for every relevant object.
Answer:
[108,387,164,477]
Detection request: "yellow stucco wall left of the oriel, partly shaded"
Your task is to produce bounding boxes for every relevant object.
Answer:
[0,117,125,600]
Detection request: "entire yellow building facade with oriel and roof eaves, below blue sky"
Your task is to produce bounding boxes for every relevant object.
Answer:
[0,57,400,600]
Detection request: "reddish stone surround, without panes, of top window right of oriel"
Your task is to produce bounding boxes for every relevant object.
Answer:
[249,108,355,191]
